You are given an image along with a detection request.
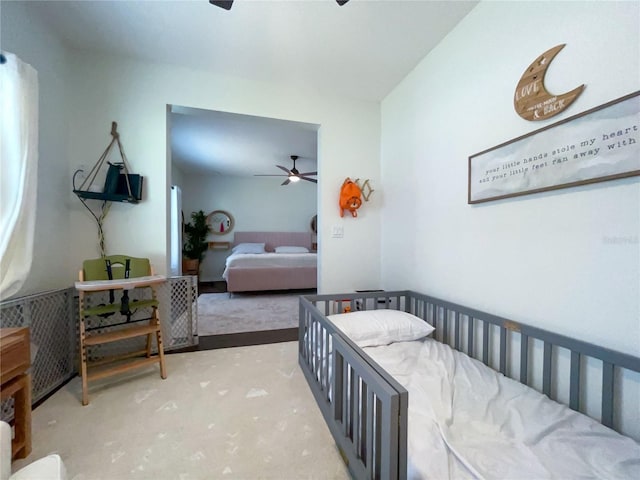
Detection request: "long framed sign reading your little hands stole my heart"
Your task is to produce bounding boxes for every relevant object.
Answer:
[467,90,640,204]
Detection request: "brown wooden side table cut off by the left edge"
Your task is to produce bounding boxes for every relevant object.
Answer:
[0,328,31,458]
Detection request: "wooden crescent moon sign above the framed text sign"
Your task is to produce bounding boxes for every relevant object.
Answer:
[513,43,584,121]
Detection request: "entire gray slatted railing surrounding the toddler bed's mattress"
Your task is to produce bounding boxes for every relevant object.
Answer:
[299,291,640,479]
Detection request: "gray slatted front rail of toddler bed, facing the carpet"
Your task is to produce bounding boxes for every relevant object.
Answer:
[299,297,408,479]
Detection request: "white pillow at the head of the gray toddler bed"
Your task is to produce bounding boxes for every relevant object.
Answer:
[327,309,435,347]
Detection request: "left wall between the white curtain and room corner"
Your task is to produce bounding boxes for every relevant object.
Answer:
[0,2,73,296]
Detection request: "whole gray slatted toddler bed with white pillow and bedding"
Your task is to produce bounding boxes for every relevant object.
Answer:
[299,291,640,479]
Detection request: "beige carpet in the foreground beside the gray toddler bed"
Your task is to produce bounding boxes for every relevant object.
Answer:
[13,342,349,480]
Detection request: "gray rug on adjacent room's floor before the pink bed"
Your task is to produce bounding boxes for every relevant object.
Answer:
[198,292,312,336]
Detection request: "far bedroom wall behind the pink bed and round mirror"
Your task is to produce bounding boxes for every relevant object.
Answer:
[182,175,318,281]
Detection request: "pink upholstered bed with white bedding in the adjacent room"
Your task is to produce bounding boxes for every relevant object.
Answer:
[222,232,318,292]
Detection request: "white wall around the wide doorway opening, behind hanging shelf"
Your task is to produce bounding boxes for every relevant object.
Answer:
[68,52,380,292]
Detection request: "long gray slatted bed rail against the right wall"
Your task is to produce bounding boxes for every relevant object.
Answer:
[404,292,640,431]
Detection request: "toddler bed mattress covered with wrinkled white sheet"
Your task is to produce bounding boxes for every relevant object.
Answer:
[365,339,640,479]
